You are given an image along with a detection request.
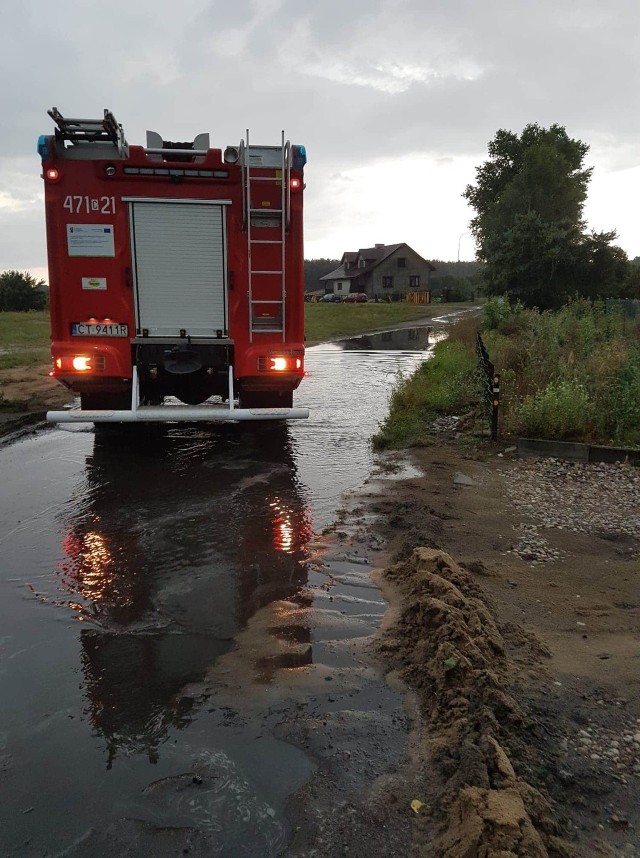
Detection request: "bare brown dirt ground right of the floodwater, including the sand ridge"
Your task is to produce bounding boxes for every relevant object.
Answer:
[363,437,640,858]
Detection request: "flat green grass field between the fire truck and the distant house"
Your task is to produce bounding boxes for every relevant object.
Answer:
[305,301,469,345]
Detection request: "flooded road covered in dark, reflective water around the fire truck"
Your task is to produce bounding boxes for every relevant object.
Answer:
[0,329,436,858]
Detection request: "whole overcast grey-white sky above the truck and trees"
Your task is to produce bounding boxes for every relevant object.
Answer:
[0,0,640,276]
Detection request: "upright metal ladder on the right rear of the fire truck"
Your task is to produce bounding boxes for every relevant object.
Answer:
[240,129,291,342]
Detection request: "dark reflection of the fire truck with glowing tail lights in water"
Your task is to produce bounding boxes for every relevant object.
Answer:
[58,427,313,767]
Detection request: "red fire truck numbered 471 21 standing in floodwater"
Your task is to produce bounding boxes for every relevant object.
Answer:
[38,107,308,423]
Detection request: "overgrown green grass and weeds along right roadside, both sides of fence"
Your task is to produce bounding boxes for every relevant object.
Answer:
[373,300,640,449]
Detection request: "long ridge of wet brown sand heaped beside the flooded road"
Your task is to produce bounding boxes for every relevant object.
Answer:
[381,548,574,858]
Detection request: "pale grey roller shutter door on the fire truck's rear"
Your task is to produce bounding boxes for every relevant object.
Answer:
[131,202,227,337]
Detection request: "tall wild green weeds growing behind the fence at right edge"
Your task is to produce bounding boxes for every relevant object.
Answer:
[484,300,640,447]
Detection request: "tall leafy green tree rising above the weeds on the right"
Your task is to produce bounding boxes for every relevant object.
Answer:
[463,124,629,309]
